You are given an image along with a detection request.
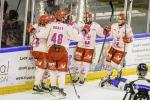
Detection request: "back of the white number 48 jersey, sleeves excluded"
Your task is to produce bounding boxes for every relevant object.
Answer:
[47,22,71,47]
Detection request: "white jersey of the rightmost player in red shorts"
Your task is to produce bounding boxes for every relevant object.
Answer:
[110,23,133,51]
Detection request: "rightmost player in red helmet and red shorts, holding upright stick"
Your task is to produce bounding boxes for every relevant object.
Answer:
[101,12,133,85]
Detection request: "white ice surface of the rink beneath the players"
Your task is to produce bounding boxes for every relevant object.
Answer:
[0,74,150,100]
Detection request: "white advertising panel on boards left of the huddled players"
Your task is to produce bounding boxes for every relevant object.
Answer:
[0,47,35,87]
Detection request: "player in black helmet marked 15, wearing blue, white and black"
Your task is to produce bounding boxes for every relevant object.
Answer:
[101,63,150,100]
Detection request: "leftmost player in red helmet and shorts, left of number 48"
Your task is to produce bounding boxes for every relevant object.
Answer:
[27,15,51,92]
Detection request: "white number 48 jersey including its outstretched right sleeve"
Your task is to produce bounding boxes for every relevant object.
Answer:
[47,22,82,48]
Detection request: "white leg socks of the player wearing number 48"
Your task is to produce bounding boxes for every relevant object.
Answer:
[49,70,66,89]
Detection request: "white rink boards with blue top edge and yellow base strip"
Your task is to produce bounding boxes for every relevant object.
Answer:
[0,34,150,94]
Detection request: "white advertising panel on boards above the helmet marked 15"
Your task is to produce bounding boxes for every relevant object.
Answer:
[126,37,150,68]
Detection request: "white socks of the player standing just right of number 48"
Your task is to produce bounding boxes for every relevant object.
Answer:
[75,61,90,81]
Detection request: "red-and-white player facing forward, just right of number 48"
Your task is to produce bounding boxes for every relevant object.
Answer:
[73,12,103,85]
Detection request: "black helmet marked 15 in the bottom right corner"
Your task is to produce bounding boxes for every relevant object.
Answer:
[137,63,148,76]
